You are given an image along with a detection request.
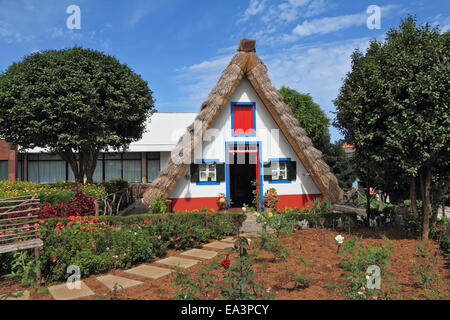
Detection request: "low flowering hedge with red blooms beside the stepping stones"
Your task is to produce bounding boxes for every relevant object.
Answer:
[0,213,246,283]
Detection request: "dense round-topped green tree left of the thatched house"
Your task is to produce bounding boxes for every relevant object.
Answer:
[0,47,154,183]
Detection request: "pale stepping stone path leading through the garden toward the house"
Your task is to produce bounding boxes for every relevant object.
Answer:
[40,234,241,300]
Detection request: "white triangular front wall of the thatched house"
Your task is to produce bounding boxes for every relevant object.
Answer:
[169,78,320,202]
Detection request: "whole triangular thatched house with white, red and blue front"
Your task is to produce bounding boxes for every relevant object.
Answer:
[144,39,343,210]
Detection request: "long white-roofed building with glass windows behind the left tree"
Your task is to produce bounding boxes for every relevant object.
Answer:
[18,112,197,183]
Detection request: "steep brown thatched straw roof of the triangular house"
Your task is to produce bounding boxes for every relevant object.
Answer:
[144,39,343,205]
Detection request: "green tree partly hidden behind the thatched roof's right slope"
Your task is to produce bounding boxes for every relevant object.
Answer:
[280,86,356,188]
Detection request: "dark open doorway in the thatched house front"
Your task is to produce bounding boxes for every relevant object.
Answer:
[229,144,258,207]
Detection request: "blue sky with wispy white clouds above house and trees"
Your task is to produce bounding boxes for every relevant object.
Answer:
[0,0,450,140]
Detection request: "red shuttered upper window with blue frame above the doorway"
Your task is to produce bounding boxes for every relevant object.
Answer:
[231,102,256,137]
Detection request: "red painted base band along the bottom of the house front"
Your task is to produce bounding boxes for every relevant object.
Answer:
[170,194,322,211]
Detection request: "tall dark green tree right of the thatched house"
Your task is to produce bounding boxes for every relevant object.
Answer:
[334,16,450,239]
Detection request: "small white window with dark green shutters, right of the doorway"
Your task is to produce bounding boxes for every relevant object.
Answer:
[264,158,297,183]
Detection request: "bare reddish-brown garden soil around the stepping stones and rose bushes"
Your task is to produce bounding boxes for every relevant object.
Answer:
[0,229,450,300]
